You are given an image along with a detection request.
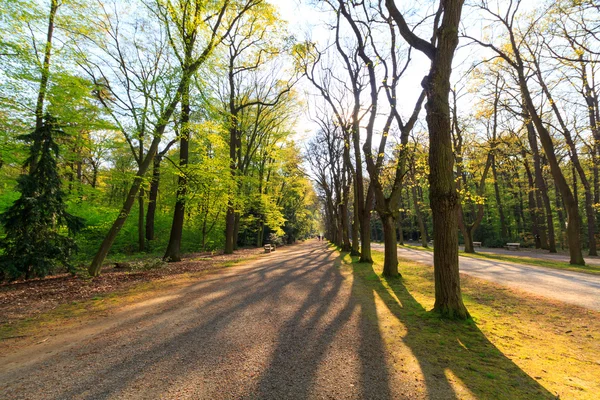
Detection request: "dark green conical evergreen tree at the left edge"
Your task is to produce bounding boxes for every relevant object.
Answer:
[0,114,83,279]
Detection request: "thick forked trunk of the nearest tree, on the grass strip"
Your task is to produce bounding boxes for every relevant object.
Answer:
[385,0,469,319]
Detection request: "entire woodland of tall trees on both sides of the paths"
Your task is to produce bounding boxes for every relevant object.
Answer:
[0,0,600,318]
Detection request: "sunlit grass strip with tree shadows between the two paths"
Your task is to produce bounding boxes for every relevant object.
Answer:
[342,248,600,399]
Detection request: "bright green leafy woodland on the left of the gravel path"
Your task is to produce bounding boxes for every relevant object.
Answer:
[0,0,319,279]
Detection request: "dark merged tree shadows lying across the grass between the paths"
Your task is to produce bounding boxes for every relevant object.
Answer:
[353,263,556,399]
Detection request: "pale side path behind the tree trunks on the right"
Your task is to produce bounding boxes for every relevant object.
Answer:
[373,244,600,311]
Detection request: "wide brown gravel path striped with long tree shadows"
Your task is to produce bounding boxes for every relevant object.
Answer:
[0,241,422,400]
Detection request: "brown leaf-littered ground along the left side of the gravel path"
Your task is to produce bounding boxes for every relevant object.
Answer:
[0,248,263,338]
